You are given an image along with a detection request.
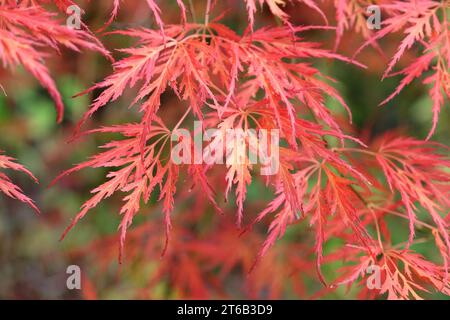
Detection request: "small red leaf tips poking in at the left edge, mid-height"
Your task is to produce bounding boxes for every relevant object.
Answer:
[0,154,39,213]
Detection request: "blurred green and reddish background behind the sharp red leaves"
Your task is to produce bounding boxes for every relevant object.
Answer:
[0,0,450,299]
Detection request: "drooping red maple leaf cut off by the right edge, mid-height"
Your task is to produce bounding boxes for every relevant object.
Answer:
[376,136,450,248]
